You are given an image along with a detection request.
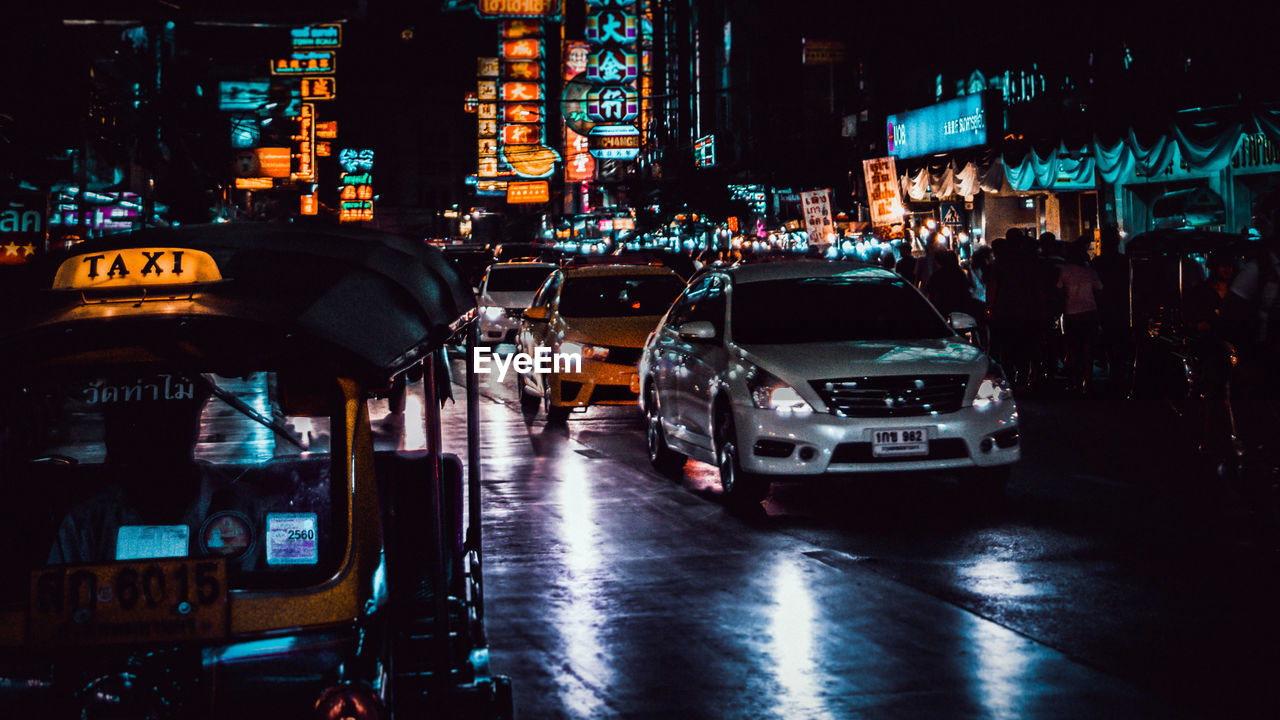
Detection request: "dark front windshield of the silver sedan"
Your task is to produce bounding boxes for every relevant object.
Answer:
[732,277,954,345]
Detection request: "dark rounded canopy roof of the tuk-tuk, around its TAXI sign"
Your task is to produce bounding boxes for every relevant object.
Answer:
[0,223,475,379]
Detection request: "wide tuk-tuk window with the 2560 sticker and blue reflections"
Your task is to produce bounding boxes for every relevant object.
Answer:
[0,369,347,602]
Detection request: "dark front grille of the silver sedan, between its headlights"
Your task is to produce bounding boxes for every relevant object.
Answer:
[809,375,969,418]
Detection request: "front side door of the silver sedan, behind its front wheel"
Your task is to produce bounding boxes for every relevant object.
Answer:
[676,274,727,446]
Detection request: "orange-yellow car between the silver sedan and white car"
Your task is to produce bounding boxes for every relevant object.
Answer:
[511,265,685,423]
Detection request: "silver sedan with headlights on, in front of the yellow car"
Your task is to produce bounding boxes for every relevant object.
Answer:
[640,261,1020,502]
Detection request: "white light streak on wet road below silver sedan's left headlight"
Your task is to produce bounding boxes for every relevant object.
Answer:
[765,557,832,719]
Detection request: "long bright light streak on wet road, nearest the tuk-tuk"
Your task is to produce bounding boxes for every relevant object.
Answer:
[552,452,613,717]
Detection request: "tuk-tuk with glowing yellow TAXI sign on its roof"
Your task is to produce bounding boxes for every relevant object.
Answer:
[0,223,511,720]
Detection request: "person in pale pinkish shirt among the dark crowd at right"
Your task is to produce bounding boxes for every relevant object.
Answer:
[1056,237,1102,393]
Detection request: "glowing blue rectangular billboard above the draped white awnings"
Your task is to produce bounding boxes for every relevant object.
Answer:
[886,95,1001,158]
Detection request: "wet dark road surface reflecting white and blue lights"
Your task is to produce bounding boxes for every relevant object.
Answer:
[422,353,1280,719]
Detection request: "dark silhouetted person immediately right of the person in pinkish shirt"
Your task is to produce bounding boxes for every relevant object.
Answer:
[1092,225,1133,398]
